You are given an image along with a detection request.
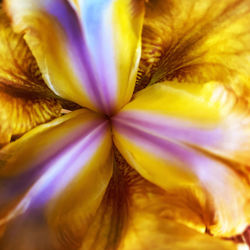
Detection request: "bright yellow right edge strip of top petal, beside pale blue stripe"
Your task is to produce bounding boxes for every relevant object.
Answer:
[112,0,144,108]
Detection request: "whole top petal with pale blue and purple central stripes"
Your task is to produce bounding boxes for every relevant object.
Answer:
[5,0,144,114]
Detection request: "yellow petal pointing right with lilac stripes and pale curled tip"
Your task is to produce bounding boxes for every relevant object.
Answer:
[112,82,250,236]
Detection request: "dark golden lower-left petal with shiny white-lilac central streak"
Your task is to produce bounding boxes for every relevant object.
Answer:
[0,110,113,250]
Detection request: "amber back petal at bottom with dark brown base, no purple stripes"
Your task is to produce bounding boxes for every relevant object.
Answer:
[81,153,237,250]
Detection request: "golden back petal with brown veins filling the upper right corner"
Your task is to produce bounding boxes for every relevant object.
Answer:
[138,0,250,96]
